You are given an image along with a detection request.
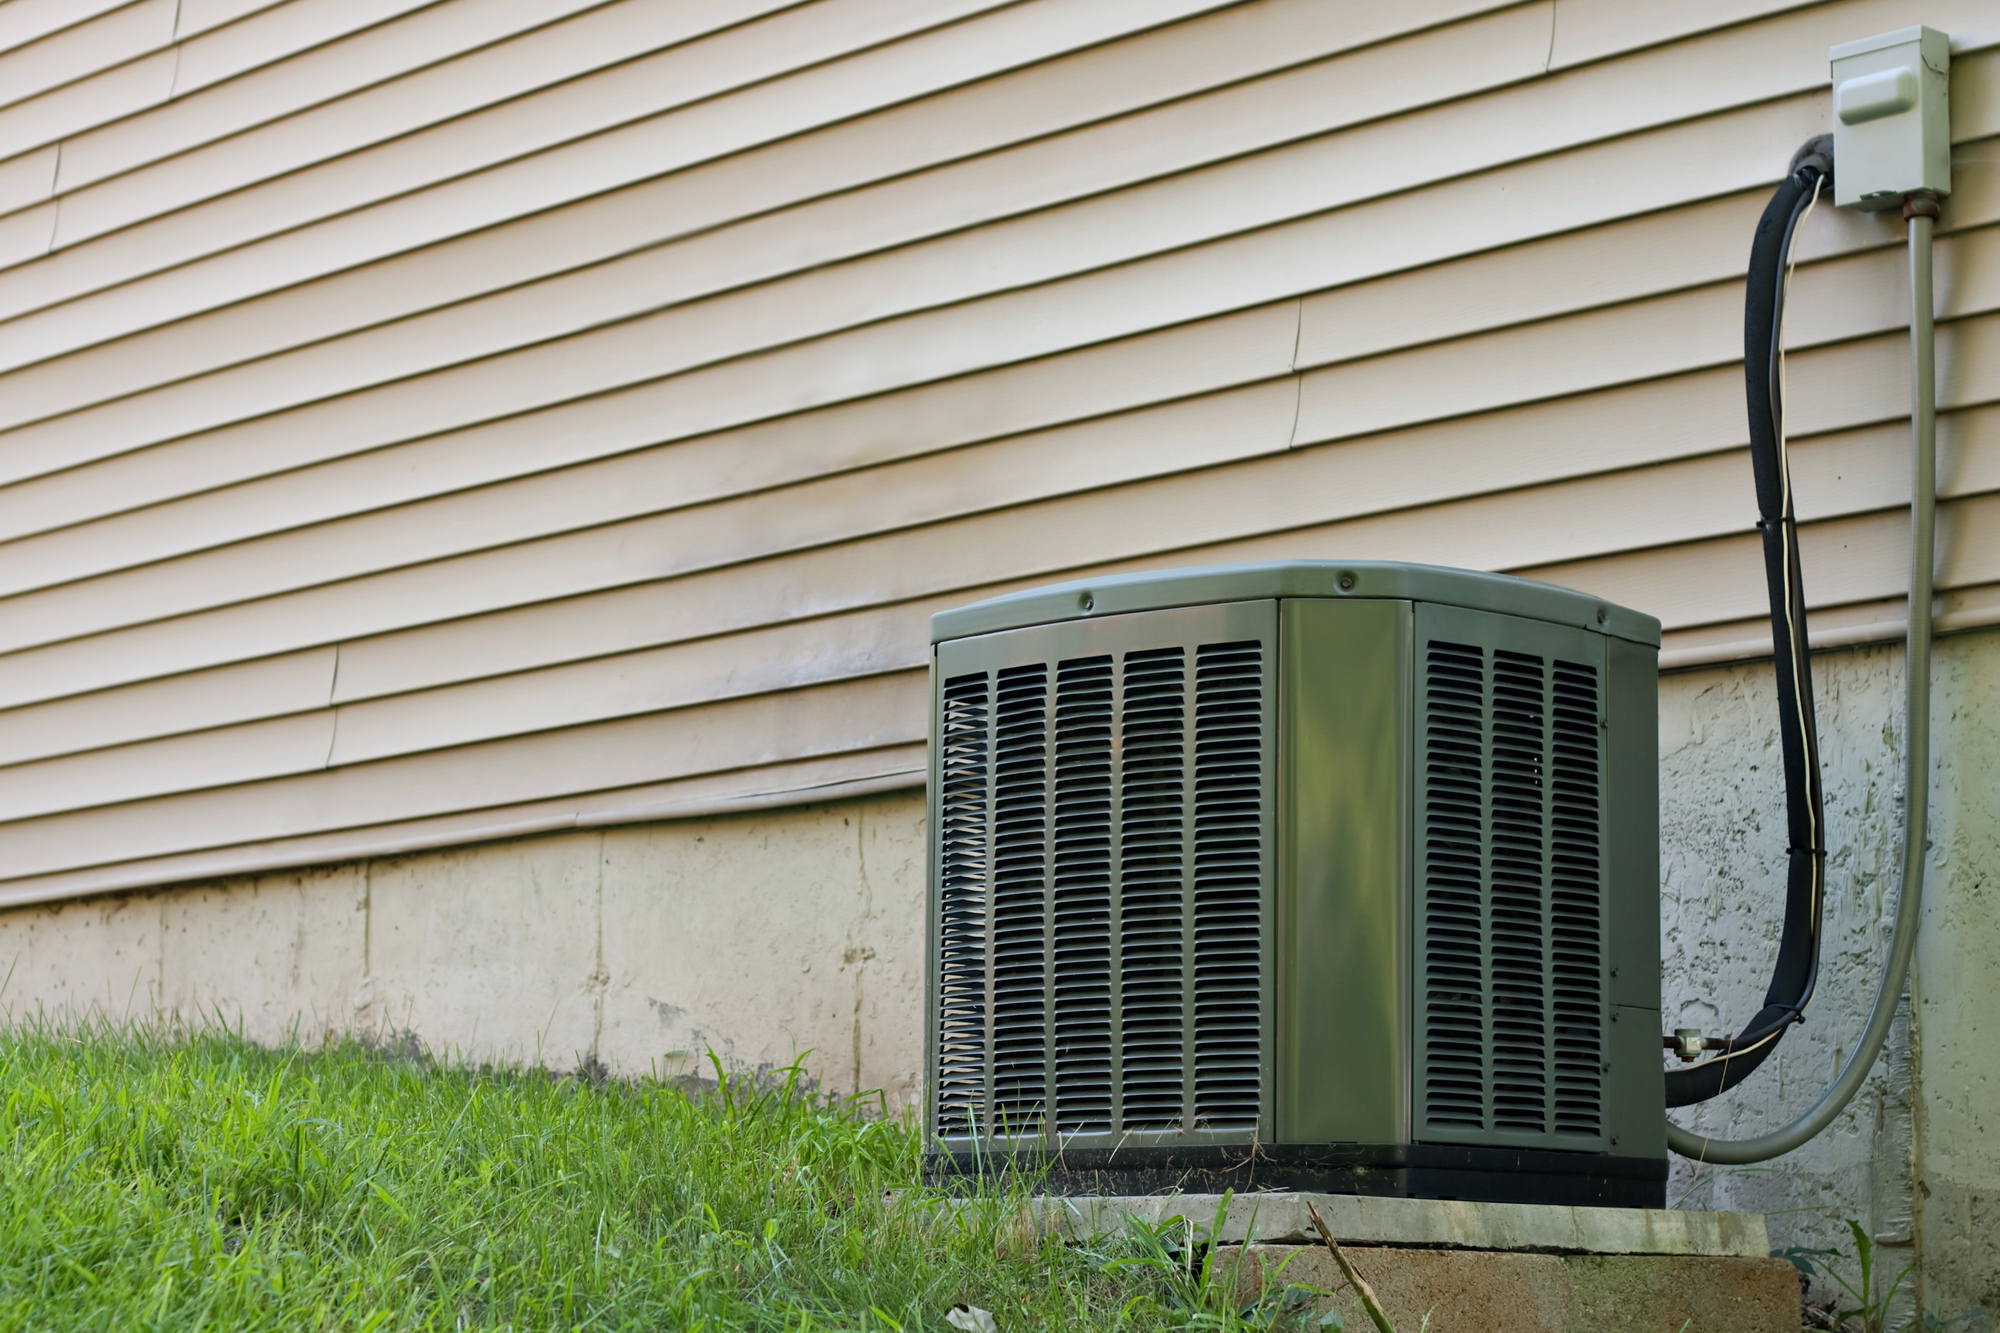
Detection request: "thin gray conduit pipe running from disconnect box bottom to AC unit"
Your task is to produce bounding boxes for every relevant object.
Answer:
[1666,194,1938,1167]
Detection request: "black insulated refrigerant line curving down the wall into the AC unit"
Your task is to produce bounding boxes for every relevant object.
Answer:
[1666,134,1834,1107]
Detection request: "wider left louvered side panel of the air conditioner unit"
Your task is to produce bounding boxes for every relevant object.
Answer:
[930,602,1276,1147]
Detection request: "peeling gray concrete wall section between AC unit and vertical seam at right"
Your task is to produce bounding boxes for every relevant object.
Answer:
[1660,646,1920,1295]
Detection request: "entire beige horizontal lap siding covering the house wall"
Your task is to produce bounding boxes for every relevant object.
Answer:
[0,0,2000,901]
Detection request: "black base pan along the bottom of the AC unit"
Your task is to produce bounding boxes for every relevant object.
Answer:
[924,1143,1666,1209]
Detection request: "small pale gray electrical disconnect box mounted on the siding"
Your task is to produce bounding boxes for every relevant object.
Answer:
[1832,28,1952,210]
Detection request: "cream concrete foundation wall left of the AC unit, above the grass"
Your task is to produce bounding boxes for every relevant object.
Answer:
[0,793,924,1107]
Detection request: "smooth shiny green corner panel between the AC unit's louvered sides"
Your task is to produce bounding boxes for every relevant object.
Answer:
[1276,598,1412,1143]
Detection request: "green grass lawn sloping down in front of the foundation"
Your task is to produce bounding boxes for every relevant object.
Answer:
[0,1023,1320,1333]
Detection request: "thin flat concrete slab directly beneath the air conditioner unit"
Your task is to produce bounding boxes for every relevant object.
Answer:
[1038,1193,1770,1259]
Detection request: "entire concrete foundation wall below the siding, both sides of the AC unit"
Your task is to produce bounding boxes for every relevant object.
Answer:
[0,632,2000,1315]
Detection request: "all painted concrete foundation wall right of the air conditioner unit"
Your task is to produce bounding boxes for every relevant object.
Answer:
[1660,632,2000,1315]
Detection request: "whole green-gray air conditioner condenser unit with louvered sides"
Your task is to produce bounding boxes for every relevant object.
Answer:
[926,560,1666,1205]
